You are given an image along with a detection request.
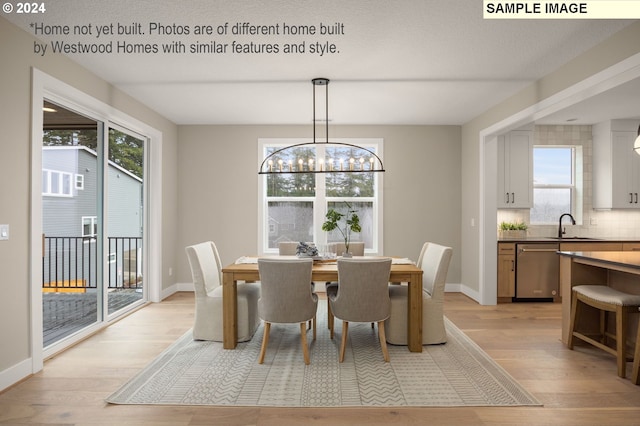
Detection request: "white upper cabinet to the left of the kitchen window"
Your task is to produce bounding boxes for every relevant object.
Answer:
[498,130,533,209]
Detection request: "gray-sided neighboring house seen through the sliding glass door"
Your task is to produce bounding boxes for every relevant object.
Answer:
[42,146,143,291]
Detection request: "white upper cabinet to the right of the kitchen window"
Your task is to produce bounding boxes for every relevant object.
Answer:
[592,120,640,209]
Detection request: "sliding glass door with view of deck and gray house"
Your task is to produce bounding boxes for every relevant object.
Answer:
[42,100,146,350]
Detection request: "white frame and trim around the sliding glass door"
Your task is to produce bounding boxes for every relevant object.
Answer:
[29,68,162,374]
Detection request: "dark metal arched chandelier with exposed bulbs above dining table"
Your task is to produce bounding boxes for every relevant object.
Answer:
[258,78,385,175]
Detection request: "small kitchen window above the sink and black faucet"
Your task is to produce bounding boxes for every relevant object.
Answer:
[530,146,576,224]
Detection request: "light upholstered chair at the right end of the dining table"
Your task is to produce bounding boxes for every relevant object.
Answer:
[385,243,452,345]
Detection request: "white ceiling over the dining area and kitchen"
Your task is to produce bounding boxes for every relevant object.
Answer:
[3,0,640,125]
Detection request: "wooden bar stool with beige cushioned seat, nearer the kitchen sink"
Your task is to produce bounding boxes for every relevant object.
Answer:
[567,285,640,378]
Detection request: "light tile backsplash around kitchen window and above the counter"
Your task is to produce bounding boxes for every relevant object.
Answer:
[497,125,640,240]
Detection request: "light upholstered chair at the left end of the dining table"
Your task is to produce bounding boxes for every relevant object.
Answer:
[185,241,260,342]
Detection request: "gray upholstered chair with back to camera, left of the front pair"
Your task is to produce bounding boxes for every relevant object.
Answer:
[258,258,318,364]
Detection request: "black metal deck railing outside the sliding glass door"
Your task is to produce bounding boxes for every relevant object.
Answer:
[42,236,142,292]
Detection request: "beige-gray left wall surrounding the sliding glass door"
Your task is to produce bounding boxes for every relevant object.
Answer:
[0,17,177,376]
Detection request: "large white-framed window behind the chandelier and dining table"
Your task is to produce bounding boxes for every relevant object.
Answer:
[258,139,382,253]
